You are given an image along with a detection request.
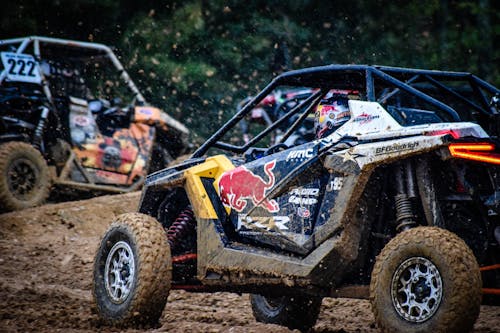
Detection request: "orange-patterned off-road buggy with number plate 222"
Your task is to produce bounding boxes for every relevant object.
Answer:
[0,37,188,210]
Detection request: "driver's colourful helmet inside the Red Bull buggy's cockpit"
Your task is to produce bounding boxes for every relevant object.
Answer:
[314,93,351,139]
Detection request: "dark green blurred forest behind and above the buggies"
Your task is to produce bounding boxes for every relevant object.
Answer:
[0,0,500,143]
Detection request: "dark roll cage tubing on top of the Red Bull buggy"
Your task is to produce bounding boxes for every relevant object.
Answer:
[191,65,500,158]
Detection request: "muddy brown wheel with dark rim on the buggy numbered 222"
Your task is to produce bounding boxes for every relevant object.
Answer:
[0,142,51,211]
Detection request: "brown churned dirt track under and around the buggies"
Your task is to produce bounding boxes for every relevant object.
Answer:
[0,193,500,333]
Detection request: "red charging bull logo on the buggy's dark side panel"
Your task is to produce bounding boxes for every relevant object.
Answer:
[219,160,280,213]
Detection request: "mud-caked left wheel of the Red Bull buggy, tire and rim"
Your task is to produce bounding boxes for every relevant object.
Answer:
[93,213,172,327]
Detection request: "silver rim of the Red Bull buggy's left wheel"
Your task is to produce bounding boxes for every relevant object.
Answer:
[104,241,135,304]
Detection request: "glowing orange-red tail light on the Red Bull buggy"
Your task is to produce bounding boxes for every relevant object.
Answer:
[448,142,500,164]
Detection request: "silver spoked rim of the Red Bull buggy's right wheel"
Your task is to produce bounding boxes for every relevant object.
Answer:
[391,257,443,323]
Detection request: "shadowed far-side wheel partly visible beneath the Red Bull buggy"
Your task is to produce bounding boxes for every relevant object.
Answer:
[250,294,321,332]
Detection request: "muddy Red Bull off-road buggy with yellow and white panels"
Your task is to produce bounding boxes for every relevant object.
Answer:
[93,65,500,332]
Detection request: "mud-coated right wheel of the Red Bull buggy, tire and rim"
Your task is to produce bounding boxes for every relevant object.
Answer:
[370,227,481,333]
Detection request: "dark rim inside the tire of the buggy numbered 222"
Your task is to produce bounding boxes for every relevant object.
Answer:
[7,158,39,199]
